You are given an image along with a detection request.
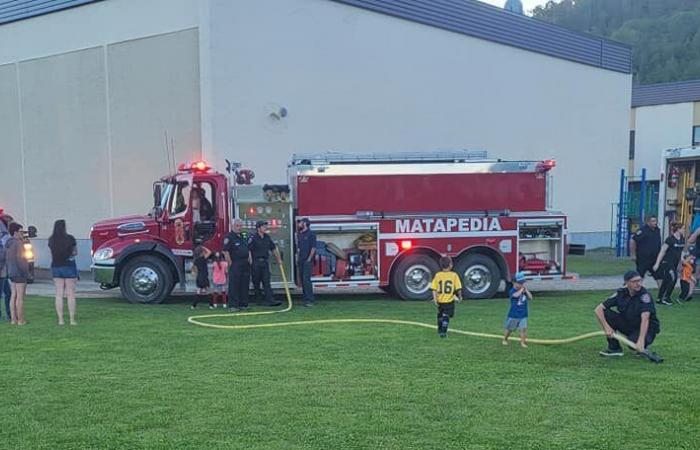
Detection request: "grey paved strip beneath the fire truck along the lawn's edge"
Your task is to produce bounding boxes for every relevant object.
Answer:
[27,274,632,298]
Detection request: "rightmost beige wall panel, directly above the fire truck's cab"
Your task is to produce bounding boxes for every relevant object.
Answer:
[108,29,201,218]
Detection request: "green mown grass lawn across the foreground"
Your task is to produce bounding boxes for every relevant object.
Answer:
[0,293,700,450]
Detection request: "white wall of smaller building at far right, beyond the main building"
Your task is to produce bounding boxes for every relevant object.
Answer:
[634,102,693,180]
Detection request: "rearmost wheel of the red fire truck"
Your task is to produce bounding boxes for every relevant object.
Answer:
[455,254,501,298]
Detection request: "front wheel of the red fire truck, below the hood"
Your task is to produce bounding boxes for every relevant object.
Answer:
[119,255,174,303]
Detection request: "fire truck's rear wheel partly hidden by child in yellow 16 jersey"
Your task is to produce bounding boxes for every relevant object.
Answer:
[391,255,440,300]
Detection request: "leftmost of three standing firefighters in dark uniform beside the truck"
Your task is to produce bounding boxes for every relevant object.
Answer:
[223,219,250,311]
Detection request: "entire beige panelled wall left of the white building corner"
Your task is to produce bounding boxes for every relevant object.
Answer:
[0,28,201,267]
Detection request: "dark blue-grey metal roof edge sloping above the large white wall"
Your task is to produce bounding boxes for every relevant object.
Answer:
[332,0,632,73]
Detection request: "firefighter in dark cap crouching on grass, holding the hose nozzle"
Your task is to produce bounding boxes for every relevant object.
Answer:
[595,270,661,356]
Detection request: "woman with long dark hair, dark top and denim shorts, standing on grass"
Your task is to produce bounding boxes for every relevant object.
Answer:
[49,219,78,325]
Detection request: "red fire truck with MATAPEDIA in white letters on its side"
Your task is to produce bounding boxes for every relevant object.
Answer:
[91,151,567,303]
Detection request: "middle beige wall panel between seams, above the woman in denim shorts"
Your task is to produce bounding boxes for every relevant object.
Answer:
[19,48,110,237]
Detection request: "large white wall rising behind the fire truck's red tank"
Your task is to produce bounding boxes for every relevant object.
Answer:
[202,0,631,246]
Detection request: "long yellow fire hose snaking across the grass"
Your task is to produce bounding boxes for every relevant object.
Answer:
[187,253,636,348]
